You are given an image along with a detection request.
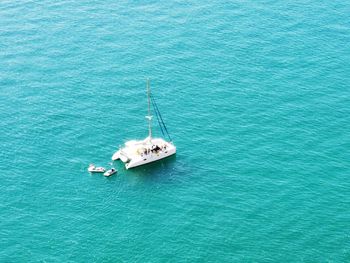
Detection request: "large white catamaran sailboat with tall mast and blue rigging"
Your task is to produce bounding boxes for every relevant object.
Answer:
[112,80,176,169]
